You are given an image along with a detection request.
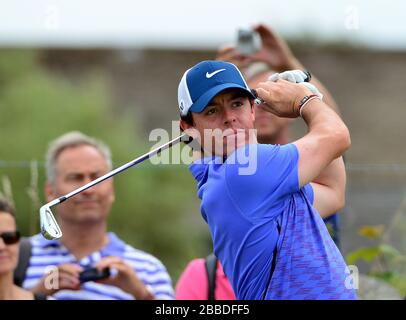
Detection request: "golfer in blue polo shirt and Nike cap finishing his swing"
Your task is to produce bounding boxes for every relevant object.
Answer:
[178,61,356,299]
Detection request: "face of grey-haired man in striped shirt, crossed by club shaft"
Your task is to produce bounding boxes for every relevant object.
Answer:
[47,145,114,224]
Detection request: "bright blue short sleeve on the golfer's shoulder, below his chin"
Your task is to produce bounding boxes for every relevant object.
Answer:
[226,144,300,216]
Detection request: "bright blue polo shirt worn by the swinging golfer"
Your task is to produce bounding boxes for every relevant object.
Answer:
[190,144,356,299]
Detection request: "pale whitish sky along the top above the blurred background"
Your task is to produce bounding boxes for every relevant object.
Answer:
[0,0,406,49]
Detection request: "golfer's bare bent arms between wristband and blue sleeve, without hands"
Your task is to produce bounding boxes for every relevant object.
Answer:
[294,99,351,217]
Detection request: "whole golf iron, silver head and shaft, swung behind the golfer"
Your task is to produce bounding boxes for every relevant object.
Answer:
[39,133,190,240]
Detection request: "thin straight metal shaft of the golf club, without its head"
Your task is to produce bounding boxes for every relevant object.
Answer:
[53,133,187,207]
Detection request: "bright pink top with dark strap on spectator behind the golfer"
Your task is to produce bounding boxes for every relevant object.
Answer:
[175,255,235,300]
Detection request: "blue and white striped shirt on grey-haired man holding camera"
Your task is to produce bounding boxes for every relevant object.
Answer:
[23,232,174,300]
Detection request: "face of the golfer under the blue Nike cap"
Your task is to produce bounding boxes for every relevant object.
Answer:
[193,90,255,156]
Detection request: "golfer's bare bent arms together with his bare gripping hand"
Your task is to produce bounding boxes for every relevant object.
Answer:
[257,80,351,216]
